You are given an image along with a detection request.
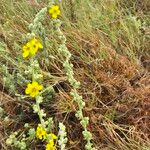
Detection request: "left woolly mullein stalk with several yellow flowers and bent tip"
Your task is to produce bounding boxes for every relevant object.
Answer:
[6,2,57,150]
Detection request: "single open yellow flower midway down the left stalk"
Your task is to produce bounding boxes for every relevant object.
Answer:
[25,81,43,97]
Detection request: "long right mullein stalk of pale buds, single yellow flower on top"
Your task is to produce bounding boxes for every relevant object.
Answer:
[49,2,96,150]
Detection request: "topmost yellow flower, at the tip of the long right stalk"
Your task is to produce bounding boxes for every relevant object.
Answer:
[48,5,60,19]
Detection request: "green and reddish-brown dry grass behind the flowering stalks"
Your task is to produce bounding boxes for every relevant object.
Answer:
[0,0,150,150]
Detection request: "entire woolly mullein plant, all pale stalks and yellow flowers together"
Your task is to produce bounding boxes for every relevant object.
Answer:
[6,1,95,150]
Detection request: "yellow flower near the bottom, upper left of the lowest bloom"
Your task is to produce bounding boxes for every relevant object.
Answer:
[36,124,47,140]
